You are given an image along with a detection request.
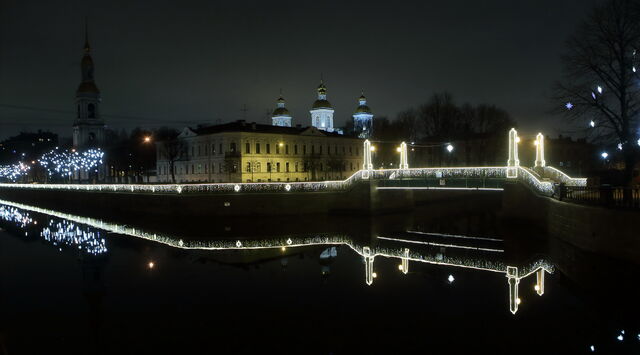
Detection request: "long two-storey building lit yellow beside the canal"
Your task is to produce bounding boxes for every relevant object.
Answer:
[157,121,363,183]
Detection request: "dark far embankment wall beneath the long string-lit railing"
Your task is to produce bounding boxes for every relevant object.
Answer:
[0,182,413,218]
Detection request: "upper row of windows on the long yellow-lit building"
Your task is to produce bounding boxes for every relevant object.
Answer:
[191,142,360,157]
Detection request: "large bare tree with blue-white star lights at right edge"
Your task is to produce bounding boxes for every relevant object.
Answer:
[554,0,640,184]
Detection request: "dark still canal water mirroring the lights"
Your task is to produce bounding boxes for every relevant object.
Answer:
[0,201,640,354]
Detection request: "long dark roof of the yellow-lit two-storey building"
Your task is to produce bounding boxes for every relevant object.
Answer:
[185,120,357,139]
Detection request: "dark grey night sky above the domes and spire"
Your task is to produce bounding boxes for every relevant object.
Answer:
[0,0,591,138]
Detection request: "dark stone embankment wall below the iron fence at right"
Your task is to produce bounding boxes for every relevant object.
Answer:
[502,183,640,263]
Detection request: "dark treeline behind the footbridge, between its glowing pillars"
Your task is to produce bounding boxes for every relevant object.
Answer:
[362,92,515,167]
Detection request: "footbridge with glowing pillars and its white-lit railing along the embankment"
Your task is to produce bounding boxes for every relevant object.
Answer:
[0,129,587,200]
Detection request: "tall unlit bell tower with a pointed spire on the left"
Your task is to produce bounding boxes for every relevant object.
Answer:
[73,22,104,149]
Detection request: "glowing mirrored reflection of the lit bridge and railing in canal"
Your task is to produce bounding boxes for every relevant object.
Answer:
[0,200,554,313]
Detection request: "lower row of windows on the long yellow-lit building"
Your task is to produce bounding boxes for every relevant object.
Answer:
[160,162,357,175]
